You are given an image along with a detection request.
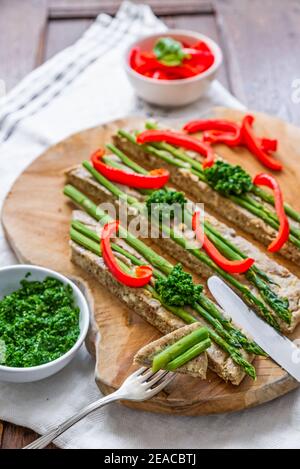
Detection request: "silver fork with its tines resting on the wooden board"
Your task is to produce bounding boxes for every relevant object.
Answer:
[23,367,175,449]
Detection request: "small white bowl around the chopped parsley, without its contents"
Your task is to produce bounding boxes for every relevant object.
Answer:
[0,265,89,383]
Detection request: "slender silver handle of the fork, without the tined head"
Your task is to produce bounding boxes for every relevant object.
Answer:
[23,391,122,449]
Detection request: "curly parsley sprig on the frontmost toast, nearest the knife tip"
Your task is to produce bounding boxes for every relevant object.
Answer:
[155,264,203,306]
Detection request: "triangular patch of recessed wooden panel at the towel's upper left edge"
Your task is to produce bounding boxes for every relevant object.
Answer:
[43,19,92,61]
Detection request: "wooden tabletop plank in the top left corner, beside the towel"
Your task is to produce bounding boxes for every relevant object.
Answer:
[0,0,47,90]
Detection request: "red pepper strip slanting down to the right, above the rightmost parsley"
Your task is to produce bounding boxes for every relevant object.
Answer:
[241,115,282,171]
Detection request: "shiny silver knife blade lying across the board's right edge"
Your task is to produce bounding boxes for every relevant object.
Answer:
[207,275,300,382]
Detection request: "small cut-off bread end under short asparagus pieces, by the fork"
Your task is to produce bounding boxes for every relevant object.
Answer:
[134,324,208,379]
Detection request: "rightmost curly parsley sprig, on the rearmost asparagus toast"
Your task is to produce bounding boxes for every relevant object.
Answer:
[204,161,253,196]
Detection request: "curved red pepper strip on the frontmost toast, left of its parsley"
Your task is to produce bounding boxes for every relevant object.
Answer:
[101,220,152,288]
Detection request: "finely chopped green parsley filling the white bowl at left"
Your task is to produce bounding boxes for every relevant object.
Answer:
[0,277,80,368]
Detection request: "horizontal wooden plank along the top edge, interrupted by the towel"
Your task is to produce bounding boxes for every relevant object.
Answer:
[49,0,214,19]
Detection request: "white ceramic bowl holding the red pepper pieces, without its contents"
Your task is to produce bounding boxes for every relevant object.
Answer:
[125,29,223,107]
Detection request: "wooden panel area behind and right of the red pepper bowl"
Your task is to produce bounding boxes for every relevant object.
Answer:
[163,14,230,89]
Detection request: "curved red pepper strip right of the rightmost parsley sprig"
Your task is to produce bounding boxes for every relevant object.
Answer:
[253,173,290,252]
